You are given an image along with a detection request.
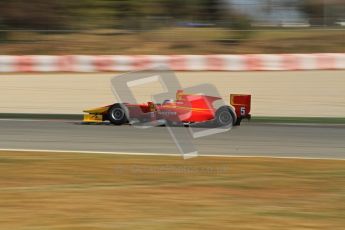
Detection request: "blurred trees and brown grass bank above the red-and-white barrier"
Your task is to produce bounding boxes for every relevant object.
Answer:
[0,0,345,55]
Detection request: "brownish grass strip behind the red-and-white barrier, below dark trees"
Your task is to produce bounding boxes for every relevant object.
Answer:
[0,27,345,55]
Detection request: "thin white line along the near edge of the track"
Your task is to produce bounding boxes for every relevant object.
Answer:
[0,148,345,161]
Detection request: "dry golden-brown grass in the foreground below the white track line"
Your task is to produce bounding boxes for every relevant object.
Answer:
[0,152,345,230]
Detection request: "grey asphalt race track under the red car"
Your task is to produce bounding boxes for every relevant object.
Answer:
[0,119,345,159]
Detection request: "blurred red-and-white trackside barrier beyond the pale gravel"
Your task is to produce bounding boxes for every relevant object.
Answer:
[0,53,345,73]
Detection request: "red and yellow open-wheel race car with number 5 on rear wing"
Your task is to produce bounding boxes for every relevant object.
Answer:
[84,90,251,126]
